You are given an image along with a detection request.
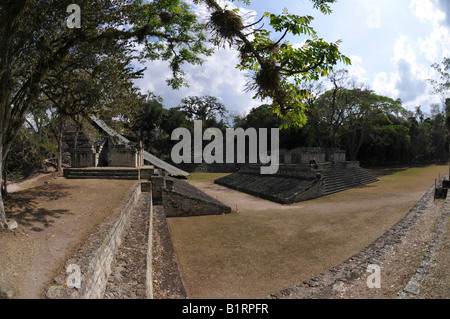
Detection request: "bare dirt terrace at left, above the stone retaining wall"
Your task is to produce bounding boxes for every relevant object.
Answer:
[0,177,135,298]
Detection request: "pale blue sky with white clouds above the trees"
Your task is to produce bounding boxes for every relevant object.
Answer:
[136,0,450,118]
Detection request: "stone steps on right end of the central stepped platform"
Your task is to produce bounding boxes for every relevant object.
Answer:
[322,163,378,195]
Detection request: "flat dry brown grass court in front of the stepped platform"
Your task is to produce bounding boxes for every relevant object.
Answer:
[168,165,448,298]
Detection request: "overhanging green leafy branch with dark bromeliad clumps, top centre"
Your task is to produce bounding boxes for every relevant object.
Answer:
[196,0,350,126]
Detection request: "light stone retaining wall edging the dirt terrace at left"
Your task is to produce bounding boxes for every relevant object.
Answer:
[46,184,141,299]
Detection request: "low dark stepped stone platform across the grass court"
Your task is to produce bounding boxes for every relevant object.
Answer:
[214,162,378,204]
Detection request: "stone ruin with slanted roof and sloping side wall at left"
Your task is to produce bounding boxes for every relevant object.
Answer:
[64,117,231,217]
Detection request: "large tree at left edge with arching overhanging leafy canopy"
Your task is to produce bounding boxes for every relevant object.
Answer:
[0,0,210,226]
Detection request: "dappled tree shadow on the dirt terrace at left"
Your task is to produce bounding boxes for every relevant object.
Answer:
[5,185,72,232]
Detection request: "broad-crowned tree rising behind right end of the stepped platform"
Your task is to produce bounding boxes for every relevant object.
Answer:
[308,70,404,160]
